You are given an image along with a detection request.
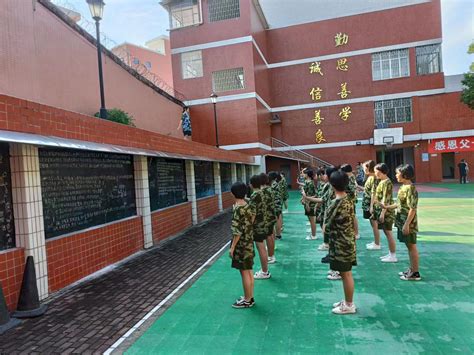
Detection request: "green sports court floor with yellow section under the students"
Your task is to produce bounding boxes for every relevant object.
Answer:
[128,184,474,354]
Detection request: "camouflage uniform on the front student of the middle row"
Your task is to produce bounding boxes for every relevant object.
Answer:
[325,196,357,271]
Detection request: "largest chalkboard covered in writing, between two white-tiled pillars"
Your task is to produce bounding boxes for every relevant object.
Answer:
[39,149,137,238]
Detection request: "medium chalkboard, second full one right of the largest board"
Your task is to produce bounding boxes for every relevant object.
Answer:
[148,158,188,211]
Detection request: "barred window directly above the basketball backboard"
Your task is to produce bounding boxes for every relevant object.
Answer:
[375,98,412,124]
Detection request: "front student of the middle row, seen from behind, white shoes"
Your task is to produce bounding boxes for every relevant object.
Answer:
[324,170,357,314]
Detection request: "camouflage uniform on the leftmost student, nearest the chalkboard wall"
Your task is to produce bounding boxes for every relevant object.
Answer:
[231,205,255,270]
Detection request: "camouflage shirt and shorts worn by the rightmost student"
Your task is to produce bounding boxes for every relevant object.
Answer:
[395,184,418,244]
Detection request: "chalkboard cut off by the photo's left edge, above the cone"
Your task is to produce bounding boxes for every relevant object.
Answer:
[0,144,15,250]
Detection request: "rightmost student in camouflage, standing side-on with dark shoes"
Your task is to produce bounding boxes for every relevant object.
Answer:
[385,164,421,281]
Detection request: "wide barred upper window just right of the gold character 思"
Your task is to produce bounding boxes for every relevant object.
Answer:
[372,49,410,80]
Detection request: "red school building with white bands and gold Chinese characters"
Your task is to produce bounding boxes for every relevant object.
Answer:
[161,0,474,185]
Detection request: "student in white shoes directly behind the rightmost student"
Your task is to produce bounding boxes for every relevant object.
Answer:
[373,163,398,263]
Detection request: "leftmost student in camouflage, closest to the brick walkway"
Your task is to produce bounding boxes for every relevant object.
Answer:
[229,182,255,308]
